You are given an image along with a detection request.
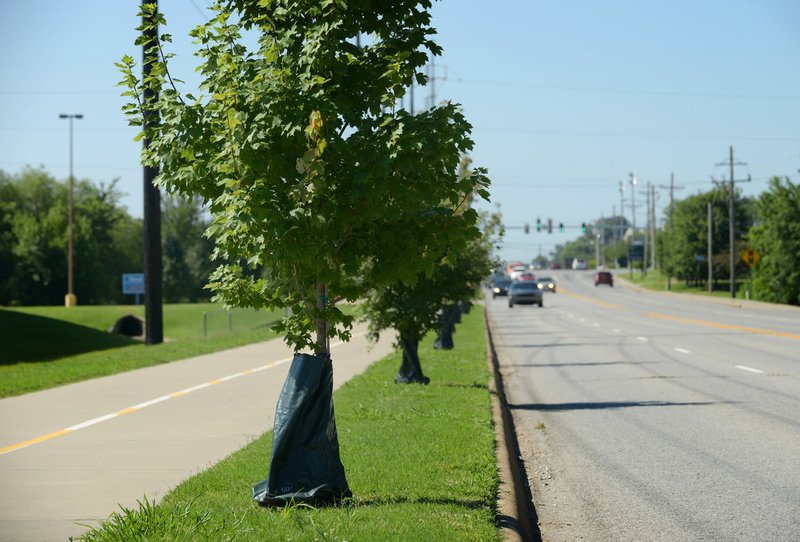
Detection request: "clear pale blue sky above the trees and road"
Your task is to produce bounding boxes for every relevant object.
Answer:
[0,0,800,262]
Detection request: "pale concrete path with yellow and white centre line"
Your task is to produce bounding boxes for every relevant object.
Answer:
[0,329,392,541]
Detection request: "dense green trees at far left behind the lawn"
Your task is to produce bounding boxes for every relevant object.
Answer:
[0,168,214,305]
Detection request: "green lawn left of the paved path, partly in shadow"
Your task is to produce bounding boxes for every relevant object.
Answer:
[0,303,279,397]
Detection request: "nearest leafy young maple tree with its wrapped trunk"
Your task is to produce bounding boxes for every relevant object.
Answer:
[119,0,487,508]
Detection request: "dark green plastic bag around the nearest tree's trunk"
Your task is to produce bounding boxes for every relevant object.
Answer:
[253,354,352,506]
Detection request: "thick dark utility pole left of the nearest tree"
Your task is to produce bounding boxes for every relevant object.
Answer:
[142,0,164,344]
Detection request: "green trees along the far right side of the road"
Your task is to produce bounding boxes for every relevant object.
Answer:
[553,177,800,305]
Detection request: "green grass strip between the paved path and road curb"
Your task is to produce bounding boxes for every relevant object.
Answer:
[76,310,500,542]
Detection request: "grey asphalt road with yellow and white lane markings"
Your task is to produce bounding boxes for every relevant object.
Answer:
[487,271,800,542]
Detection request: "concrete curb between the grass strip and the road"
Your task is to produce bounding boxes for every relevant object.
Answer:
[483,307,542,542]
